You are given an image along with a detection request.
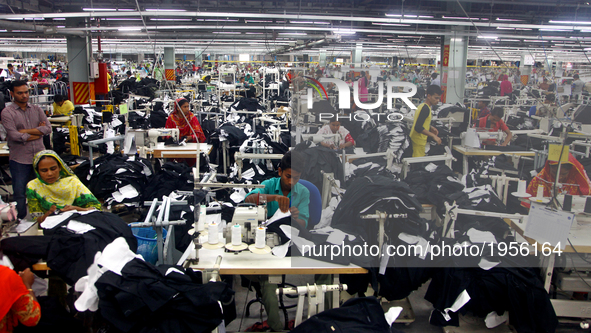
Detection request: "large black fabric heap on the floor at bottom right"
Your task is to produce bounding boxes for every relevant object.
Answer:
[425,265,558,332]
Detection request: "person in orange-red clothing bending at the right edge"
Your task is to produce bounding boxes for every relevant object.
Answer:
[527,153,591,197]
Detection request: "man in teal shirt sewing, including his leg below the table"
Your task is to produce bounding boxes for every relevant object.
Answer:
[244,151,310,332]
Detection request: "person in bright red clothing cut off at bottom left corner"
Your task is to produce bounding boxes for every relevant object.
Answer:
[0,266,41,332]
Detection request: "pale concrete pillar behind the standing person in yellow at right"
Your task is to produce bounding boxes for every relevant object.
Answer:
[441,27,470,105]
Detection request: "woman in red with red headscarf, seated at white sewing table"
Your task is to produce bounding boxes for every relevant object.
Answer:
[166,98,205,143]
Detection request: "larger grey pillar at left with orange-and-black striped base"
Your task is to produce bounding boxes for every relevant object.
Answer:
[66,18,95,105]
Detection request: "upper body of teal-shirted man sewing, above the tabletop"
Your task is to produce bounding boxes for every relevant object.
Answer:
[245,151,310,228]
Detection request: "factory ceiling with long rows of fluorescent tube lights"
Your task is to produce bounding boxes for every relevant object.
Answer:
[0,0,591,63]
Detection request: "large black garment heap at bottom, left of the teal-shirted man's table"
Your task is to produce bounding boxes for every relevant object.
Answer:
[95,259,235,333]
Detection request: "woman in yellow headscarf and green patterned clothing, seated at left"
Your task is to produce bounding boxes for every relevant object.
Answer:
[26,150,101,223]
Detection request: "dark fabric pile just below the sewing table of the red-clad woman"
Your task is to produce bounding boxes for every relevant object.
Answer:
[141,162,193,200]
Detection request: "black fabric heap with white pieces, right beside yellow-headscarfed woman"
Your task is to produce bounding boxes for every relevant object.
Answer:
[75,154,154,206]
